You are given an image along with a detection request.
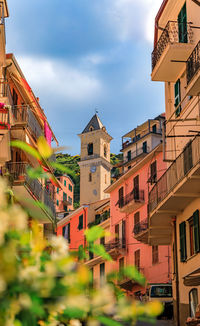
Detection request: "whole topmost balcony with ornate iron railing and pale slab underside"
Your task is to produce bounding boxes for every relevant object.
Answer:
[151,21,194,82]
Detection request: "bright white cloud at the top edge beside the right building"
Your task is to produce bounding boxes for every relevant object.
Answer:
[102,0,162,42]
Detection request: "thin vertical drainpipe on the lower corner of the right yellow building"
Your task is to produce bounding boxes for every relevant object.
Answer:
[173,217,181,326]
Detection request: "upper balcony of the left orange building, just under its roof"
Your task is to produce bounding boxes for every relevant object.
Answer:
[12,105,43,140]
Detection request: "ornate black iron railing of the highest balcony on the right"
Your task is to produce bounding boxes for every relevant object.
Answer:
[152,21,193,70]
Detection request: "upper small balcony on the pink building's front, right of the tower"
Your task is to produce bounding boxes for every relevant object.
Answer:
[117,189,144,213]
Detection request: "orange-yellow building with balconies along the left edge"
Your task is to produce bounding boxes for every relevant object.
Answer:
[0,0,56,236]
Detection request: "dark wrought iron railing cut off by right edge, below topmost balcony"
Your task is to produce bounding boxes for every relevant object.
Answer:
[186,41,200,84]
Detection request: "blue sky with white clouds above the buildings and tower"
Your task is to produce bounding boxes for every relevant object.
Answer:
[6,0,165,155]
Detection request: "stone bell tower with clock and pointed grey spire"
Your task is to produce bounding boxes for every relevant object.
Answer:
[79,114,112,205]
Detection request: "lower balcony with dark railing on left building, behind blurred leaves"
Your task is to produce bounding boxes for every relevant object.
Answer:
[3,162,56,221]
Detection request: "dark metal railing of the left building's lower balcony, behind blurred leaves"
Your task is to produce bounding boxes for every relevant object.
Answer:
[4,162,56,216]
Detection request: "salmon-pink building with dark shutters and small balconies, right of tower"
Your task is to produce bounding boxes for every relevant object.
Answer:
[106,144,171,294]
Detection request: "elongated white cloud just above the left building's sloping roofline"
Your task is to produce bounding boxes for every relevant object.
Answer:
[18,56,102,102]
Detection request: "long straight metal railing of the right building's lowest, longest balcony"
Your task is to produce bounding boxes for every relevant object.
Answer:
[149,136,200,213]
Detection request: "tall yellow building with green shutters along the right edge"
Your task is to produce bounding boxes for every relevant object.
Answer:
[149,0,200,325]
